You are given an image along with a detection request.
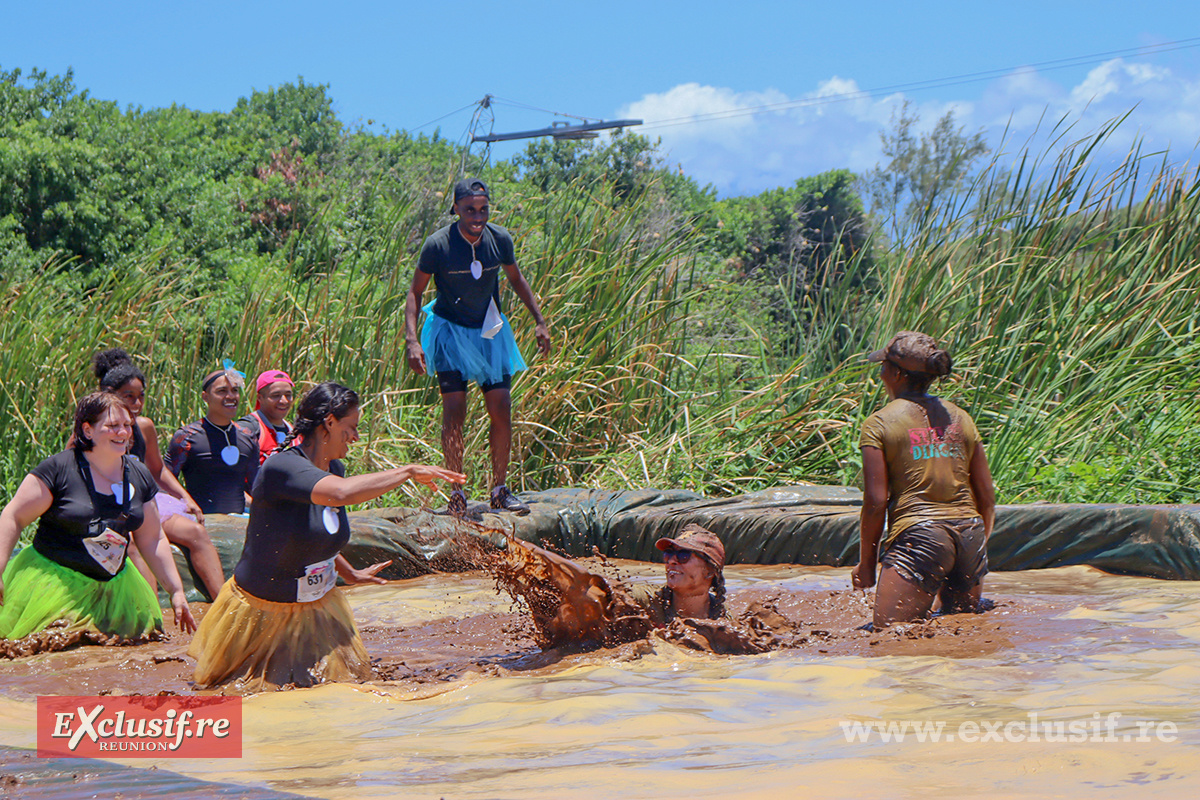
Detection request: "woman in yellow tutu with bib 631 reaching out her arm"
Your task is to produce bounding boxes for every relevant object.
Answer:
[188,383,466,691]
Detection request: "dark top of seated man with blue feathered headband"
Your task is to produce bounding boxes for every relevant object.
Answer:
[163,419,258,513]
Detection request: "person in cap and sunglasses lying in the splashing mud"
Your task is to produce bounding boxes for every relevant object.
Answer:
[500,524,726,646]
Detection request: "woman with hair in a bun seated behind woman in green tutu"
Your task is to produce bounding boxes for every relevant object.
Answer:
[92,348,224,601]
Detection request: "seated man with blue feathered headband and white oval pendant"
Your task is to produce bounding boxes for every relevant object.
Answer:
[167,361,258,515]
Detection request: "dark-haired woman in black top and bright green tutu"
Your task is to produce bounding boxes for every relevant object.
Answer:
[0,392,196,649]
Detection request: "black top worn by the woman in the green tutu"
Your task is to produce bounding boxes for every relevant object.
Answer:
[30,450,158,581]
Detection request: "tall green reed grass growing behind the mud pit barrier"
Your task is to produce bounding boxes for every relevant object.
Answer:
[7,118,1200,513]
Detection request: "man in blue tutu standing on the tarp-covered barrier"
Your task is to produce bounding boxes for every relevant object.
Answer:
[404,179,550,516]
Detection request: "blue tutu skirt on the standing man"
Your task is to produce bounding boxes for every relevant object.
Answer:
[421,302,528,386]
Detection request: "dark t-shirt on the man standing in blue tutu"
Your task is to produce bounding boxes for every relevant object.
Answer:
[416,223,516,327]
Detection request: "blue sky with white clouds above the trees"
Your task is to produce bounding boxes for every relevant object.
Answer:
[0,0,1200,194]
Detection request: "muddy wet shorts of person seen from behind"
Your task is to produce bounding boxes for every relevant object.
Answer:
[881,517,988,595]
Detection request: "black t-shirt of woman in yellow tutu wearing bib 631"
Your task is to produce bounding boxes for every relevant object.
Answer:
[233,447,350,603]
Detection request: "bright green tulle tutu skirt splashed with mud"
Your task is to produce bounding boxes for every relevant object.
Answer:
[0,547,162,649]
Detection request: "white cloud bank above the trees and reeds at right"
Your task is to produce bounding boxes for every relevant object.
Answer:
[618,59,1200,196]
